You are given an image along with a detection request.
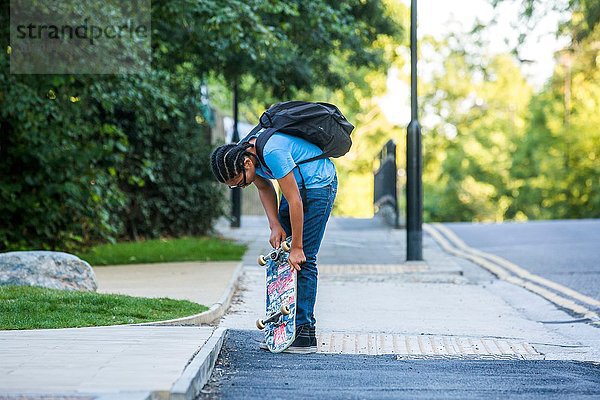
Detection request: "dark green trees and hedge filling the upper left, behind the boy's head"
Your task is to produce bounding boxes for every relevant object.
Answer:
[0,0,399,251]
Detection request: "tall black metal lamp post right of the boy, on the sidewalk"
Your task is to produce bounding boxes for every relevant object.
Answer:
[406,0,423,261]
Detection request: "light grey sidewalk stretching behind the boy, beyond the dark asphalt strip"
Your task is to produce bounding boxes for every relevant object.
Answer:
[221,217,600,361]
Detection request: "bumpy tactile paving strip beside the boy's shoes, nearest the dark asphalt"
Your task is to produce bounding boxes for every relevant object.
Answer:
[317,332,544,360]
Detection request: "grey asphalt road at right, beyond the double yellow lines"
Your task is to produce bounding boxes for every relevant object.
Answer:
[444,219,600,300]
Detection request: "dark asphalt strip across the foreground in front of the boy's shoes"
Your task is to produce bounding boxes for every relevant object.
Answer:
[199,331,600,400]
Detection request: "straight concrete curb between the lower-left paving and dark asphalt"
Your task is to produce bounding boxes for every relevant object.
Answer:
[169,328,227,400]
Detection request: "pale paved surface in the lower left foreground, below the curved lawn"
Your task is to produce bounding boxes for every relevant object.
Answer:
[0,326,213,399]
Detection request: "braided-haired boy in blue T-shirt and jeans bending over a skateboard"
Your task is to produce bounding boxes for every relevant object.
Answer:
[211,132,337,353]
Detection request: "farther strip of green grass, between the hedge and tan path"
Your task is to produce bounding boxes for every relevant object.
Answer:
[77,237,246,267]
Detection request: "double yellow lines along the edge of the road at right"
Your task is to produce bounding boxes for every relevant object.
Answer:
[423,224,600,325]
